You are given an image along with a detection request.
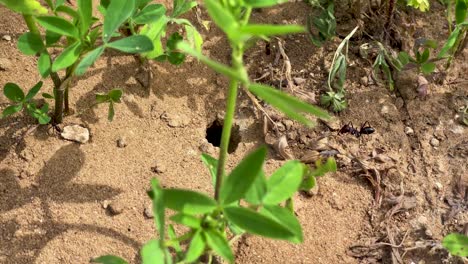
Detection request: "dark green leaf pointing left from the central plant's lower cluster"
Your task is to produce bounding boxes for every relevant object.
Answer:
[163,189,216,215]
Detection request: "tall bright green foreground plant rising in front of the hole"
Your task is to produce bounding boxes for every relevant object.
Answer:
[94,0,336,263]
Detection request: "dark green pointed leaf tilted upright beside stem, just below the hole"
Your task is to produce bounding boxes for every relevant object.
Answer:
[219,147,266,205]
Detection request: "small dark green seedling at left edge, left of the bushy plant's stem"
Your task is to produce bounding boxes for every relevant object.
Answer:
[2,82,50,124]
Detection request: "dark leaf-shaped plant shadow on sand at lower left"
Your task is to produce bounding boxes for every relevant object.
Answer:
[0,143,141,263]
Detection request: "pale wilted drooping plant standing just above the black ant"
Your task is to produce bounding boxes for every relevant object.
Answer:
[320,27,358,112]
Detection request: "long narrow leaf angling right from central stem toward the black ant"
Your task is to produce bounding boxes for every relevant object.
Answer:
[248,84,330,126]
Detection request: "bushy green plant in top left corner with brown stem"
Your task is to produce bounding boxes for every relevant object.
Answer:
[0,0,153,123]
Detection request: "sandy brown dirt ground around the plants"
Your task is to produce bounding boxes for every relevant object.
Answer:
[0,1,468,263]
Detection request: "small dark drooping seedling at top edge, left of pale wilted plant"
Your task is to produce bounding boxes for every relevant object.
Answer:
[307,3,336,47]
